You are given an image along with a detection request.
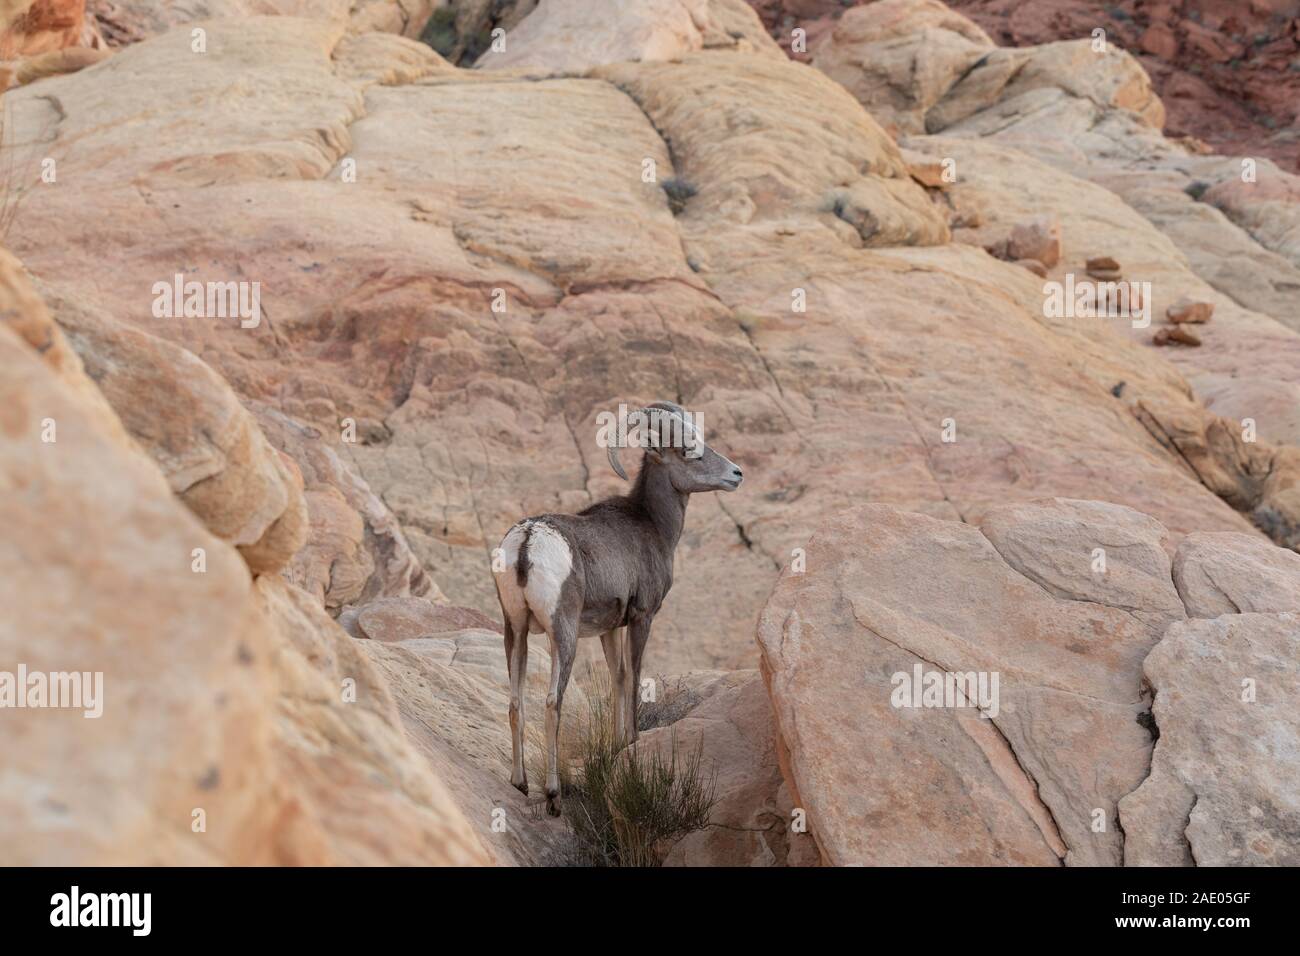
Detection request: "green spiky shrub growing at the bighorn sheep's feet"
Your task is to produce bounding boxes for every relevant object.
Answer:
[543,665,716,866]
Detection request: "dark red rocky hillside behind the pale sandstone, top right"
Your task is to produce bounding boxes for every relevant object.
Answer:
[750,0,1300,170]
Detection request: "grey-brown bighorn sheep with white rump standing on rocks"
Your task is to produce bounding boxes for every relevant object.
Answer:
[493,402,741,816]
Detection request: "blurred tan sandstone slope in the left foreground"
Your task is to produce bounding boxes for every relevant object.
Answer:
[0,240,488,865]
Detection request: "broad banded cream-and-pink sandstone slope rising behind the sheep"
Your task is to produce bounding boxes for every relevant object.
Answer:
[10,1,1287,672]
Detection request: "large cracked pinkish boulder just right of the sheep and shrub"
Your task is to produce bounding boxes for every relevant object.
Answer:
[759,503,1177,865]
